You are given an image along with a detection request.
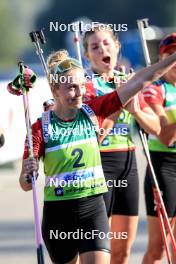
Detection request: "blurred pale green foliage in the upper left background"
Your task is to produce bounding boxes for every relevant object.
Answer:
[0,0,46,69]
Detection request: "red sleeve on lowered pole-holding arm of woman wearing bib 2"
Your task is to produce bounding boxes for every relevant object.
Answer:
[23,120,44,159]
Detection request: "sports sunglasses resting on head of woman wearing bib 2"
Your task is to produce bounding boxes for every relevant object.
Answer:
[54,58,82,74]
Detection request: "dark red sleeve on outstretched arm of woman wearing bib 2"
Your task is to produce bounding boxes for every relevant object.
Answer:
[87,91,122,127]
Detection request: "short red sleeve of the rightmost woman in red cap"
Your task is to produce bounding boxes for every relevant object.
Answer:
[142,84,164,105]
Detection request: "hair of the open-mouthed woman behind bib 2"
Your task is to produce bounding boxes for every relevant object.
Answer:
[83,24,120,52]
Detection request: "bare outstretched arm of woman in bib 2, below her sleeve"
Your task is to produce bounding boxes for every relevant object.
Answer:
[117,53,176,105]
